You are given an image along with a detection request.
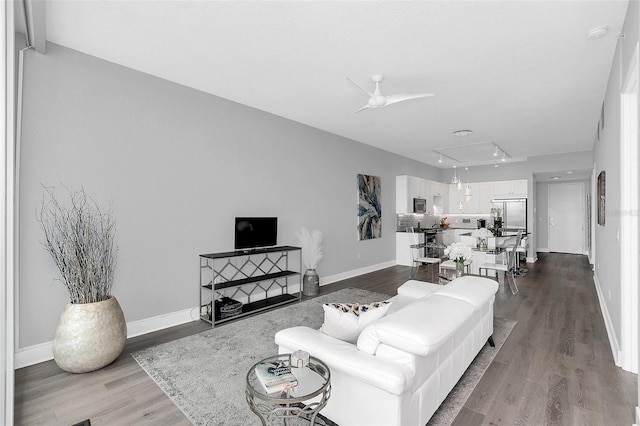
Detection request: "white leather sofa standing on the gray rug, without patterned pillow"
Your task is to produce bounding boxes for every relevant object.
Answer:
[275,276,498,426]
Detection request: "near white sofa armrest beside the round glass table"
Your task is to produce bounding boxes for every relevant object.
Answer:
[275,326,414,395]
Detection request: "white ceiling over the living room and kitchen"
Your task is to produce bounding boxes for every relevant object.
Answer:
[17,0,627,167]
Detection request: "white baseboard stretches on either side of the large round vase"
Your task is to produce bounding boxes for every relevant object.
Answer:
[14,307,200,369]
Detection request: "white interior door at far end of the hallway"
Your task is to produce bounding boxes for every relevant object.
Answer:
[549,183,584,254]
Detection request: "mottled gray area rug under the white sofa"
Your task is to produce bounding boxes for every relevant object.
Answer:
[132,288,515,426]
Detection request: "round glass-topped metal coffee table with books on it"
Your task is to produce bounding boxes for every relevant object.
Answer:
[245,354,331,426]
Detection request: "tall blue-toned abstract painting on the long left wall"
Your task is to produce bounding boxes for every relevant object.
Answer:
[358,174,382,241]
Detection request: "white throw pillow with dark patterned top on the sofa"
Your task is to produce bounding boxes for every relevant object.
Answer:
[320,301,391,344]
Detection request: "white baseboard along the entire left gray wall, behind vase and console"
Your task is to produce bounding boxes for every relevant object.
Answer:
[14,260,396,369]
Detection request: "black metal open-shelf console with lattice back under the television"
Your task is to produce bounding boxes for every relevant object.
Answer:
[200,246,302,326]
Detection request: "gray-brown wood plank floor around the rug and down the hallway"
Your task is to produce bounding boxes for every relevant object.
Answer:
[15,254,637,426]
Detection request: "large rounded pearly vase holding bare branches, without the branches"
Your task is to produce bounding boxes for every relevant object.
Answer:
[53,296,127,373]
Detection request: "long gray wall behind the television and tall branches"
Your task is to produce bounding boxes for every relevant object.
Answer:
[18,44,441,348]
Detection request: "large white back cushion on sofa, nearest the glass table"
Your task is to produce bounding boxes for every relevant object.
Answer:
[357,293,475,356]
